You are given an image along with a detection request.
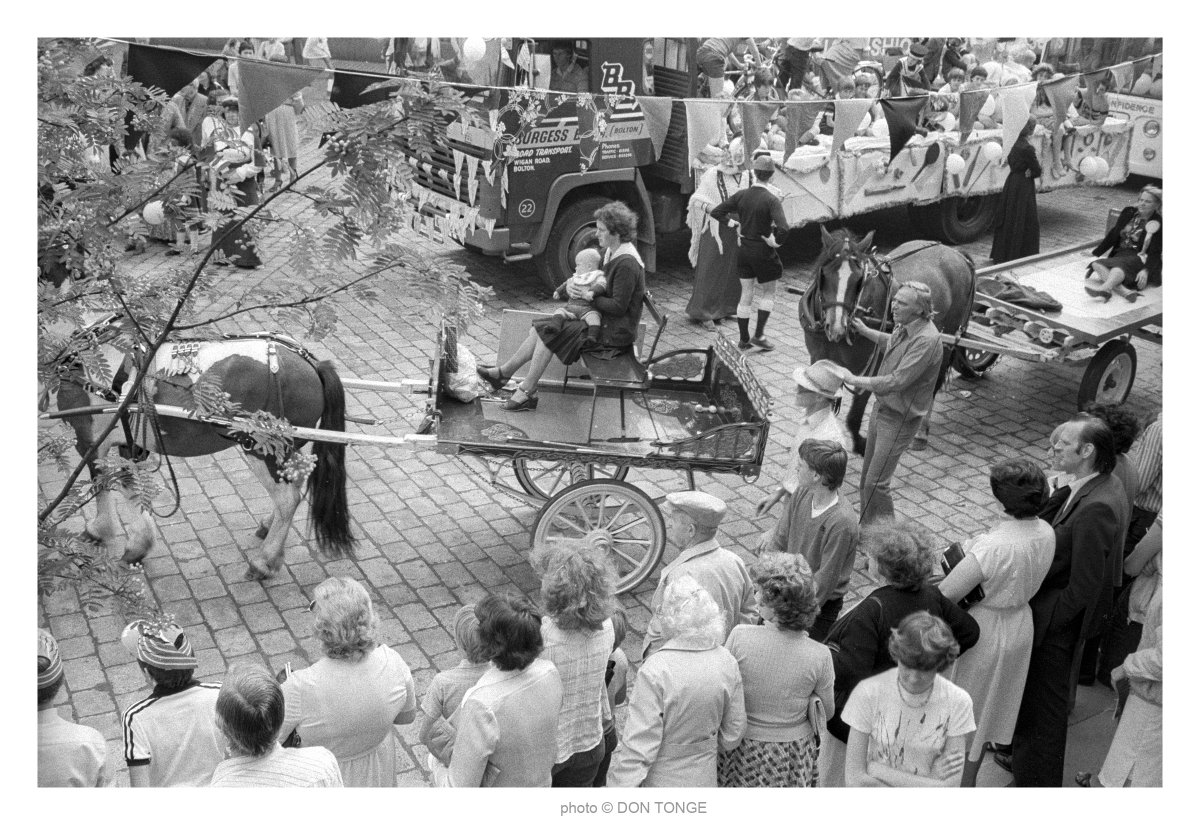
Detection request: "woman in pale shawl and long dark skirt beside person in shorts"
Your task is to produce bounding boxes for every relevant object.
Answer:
[685,138,749,325]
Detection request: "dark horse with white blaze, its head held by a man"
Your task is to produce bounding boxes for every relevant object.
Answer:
[800,227,976,454]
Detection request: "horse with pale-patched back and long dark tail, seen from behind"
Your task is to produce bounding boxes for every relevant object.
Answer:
[56,321,355,579]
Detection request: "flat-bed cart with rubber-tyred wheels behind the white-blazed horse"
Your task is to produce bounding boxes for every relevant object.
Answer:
[947,230,1163,408]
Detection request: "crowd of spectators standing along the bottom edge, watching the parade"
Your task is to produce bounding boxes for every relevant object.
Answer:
[38,395,1162,787]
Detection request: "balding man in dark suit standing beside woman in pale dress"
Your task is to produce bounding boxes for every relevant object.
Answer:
[1013,414,1129,788]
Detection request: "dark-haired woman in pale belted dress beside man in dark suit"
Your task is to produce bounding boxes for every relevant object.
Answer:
[938,458,1054,788]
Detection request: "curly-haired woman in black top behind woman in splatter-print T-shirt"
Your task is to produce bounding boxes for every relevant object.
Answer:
[821,520,979,787]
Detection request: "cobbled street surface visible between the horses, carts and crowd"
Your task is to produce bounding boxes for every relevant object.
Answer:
[40,91,1162,785]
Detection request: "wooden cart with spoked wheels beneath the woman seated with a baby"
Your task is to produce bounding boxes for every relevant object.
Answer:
[428,313,770,592]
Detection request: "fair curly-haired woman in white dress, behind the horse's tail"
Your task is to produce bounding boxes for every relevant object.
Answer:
[278,578,416,788]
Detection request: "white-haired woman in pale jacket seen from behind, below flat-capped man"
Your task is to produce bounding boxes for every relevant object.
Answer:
[608,574,746,788]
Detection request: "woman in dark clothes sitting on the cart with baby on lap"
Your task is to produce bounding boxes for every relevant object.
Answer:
[479,200,646,413]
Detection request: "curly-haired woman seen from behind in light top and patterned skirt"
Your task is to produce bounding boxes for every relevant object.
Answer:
[716,553,833,788]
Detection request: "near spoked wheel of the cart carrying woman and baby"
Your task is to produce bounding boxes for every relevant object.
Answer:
[530,481,667,594]
